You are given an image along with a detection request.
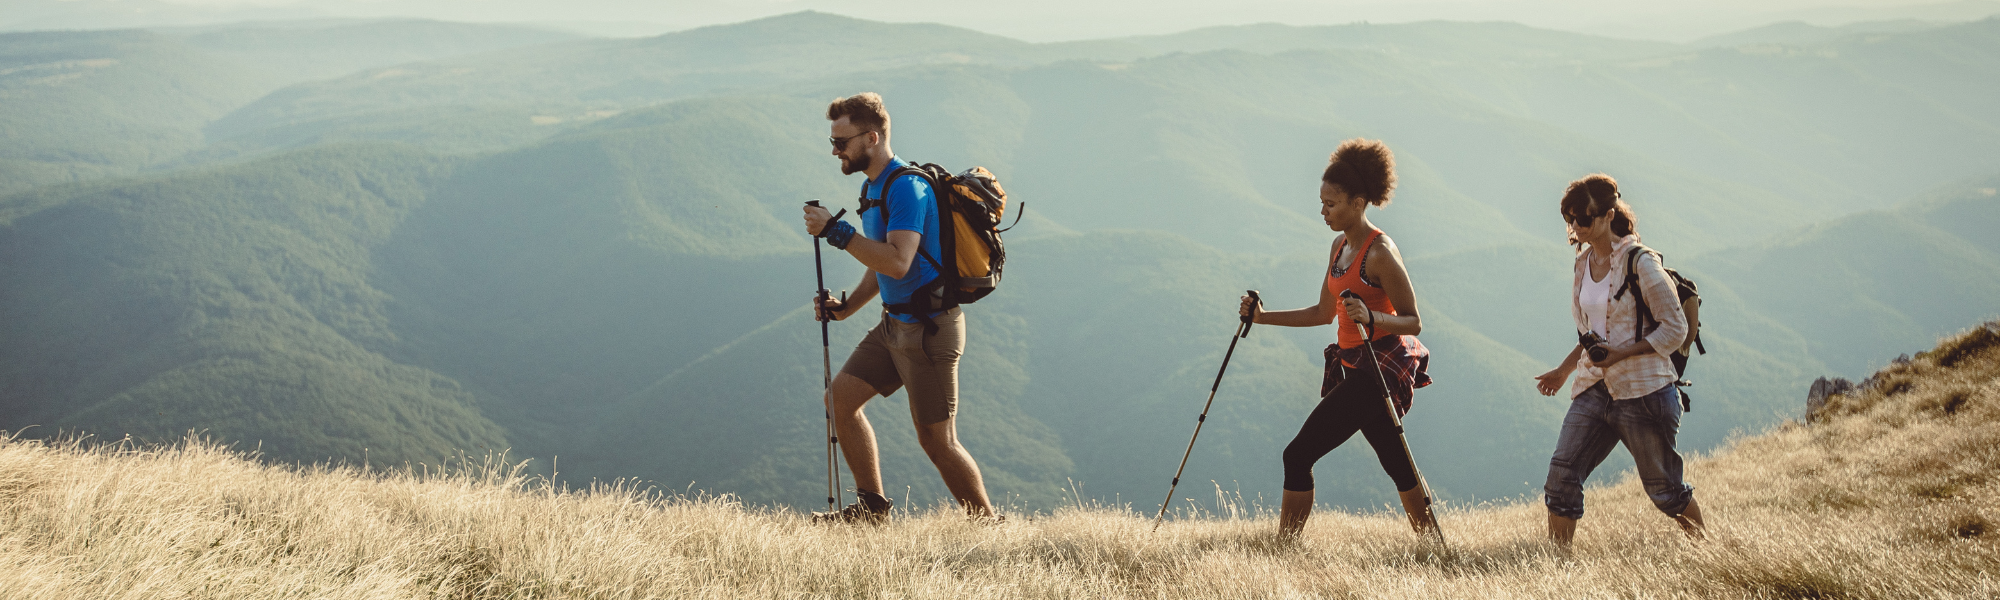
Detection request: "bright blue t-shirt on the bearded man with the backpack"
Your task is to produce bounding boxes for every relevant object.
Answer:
[862,156,942,322]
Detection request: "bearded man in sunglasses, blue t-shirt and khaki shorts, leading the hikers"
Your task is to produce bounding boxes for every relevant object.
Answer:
[788,92,994,522]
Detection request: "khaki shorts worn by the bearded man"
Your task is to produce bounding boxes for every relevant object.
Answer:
[840,308,966,424]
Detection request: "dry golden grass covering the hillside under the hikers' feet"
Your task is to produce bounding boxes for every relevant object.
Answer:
[0,330,2000,600]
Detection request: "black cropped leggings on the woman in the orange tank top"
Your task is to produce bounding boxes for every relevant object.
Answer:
[1284,366,1416,492]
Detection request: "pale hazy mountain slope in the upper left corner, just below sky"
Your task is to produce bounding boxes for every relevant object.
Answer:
[0,20,600,194]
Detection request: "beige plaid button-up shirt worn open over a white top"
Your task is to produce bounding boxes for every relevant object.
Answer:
[1570,234,1688,400]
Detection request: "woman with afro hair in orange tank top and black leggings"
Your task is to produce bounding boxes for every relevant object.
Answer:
[1240,138,1438,538]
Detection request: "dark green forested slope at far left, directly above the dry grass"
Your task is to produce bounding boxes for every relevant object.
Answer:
[0,146,506,464]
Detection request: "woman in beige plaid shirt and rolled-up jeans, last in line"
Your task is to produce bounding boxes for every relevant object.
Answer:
[1536,174,1702,548]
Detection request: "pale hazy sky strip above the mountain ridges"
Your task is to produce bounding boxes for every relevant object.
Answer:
[11,0,2000,42]
